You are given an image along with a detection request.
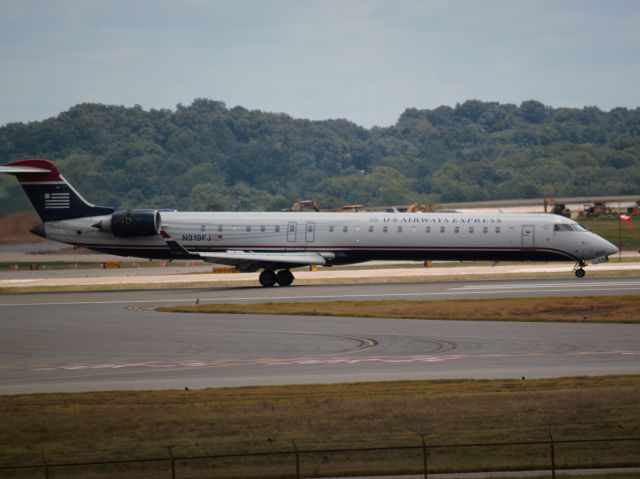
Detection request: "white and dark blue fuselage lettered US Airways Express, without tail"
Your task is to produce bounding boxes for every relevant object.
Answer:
[45,211,617,264]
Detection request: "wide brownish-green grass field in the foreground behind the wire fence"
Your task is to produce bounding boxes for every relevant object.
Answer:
[0,376,640,478]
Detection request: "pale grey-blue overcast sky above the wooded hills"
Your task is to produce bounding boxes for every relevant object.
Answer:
[0,0,640,127]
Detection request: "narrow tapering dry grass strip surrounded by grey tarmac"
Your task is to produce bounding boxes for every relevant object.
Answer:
[158,295,640,323]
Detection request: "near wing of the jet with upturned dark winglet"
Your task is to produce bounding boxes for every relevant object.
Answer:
[160,230,335,272]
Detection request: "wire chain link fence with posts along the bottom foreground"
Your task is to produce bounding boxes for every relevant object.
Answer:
[0,433,640,479]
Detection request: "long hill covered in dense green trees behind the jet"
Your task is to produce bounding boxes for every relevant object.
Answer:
[0,99,640,214]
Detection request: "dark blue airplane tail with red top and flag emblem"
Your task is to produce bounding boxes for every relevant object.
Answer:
[0,158,114,222]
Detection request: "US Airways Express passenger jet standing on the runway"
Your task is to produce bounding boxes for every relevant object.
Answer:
[0,158,618,287]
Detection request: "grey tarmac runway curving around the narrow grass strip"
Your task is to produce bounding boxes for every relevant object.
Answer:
[0,277,640,394]
